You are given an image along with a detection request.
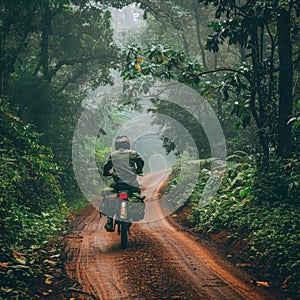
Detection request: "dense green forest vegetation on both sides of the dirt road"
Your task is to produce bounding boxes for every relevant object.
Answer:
[0,0,300,299]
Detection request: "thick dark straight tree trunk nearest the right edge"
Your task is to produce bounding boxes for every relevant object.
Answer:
[277,9,293,157]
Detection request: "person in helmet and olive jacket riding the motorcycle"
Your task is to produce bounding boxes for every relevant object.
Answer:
[103,135,144,231]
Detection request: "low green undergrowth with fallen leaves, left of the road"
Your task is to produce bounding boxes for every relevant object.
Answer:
[0,105,84,299]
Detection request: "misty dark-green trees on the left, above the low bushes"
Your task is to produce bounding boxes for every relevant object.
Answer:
[0,0,132,198]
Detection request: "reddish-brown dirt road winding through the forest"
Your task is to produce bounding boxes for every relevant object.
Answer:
[62,174,280,300]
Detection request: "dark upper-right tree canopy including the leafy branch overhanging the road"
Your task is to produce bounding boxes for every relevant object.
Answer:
[120,1,299,157]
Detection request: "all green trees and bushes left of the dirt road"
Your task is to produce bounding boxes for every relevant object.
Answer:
[0,0,124,299]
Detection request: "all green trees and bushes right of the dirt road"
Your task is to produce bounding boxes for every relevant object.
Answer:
[119,1,300,297]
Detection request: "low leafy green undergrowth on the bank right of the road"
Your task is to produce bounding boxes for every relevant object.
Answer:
[167,155,300,295]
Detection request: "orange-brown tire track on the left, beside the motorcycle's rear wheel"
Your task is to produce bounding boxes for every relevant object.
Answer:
[65,206,129,299]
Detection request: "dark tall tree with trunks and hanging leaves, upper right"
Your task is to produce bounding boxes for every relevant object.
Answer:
[200,0,299,156]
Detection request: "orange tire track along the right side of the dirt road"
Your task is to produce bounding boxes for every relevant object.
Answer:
[137,174,279,300]
